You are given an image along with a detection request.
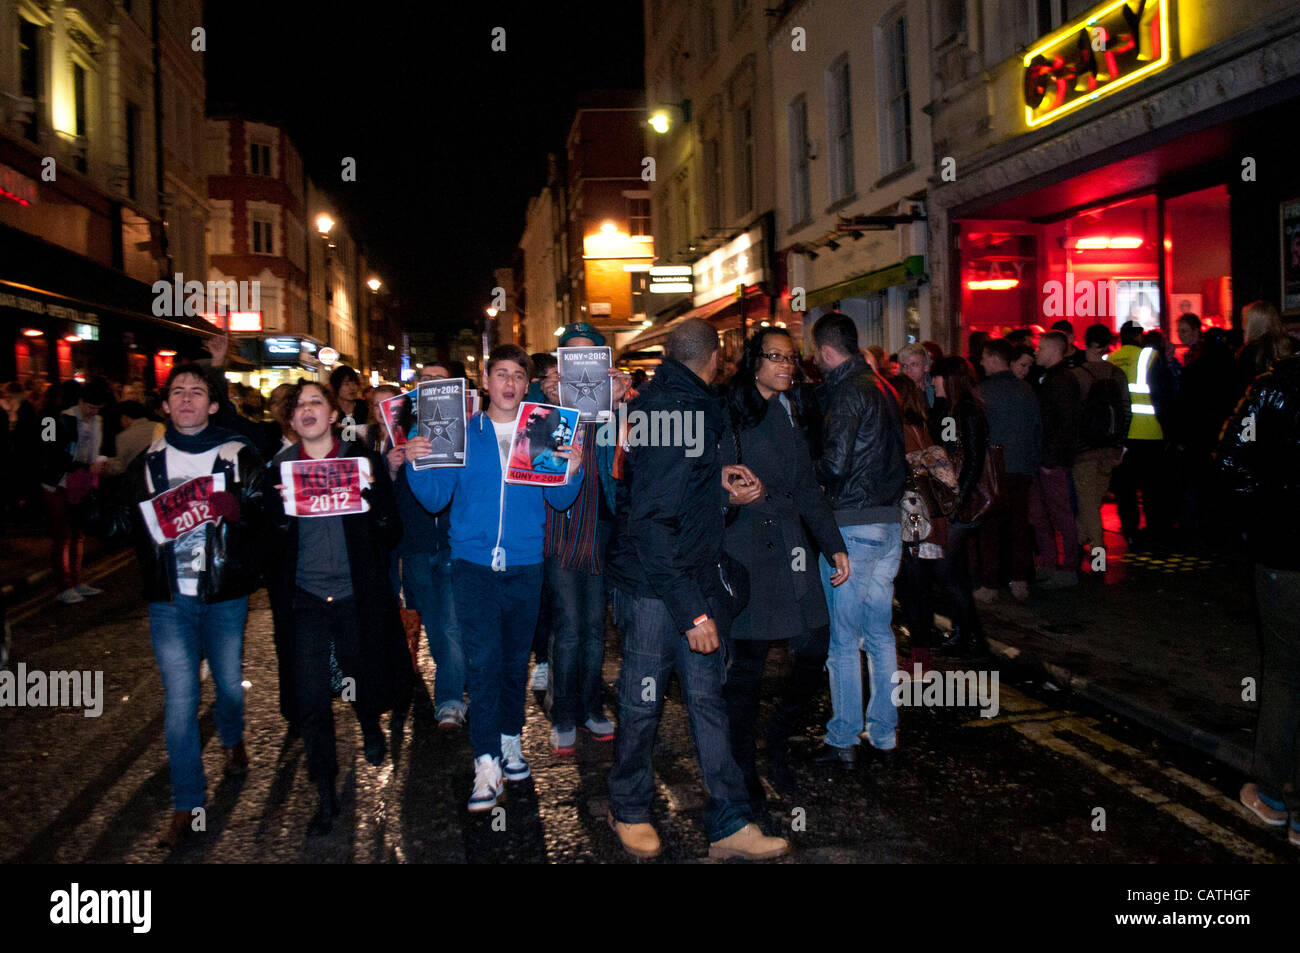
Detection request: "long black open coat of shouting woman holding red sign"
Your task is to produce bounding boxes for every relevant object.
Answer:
[264,442,412,714]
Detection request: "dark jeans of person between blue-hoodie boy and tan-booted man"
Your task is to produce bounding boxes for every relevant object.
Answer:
[546,556,605,728]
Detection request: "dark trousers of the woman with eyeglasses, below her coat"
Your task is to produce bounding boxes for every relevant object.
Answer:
[723,625,831,788]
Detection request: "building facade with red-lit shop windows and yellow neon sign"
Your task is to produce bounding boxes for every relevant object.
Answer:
[930,0,1300,347]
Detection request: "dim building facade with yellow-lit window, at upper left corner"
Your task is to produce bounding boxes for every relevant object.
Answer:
[0,0,211,385]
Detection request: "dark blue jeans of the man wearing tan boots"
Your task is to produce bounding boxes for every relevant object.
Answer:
[610,589,754,841]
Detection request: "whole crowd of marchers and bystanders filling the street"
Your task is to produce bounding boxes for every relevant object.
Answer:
[3,302,1300,859]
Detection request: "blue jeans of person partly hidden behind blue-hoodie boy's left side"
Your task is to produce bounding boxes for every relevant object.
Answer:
[402,550,465,718]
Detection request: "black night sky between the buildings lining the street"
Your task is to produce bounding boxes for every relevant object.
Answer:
[205,0,644,330]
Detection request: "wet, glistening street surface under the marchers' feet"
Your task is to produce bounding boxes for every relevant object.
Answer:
[0,562,1300,863]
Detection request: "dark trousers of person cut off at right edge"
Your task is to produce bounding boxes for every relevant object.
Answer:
[1255,566,1300,816]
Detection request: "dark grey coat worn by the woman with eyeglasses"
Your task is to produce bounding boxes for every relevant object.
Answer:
[722,397,848,641]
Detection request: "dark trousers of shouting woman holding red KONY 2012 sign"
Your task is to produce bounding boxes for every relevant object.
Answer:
[293,588,380,785]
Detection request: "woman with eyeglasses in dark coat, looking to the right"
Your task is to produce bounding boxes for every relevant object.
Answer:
[722,328,849,802]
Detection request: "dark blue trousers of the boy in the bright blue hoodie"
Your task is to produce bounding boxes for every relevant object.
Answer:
[451,559,542,758]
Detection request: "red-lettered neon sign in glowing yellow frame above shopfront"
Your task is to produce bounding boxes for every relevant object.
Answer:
[1024,0,1173,129]
